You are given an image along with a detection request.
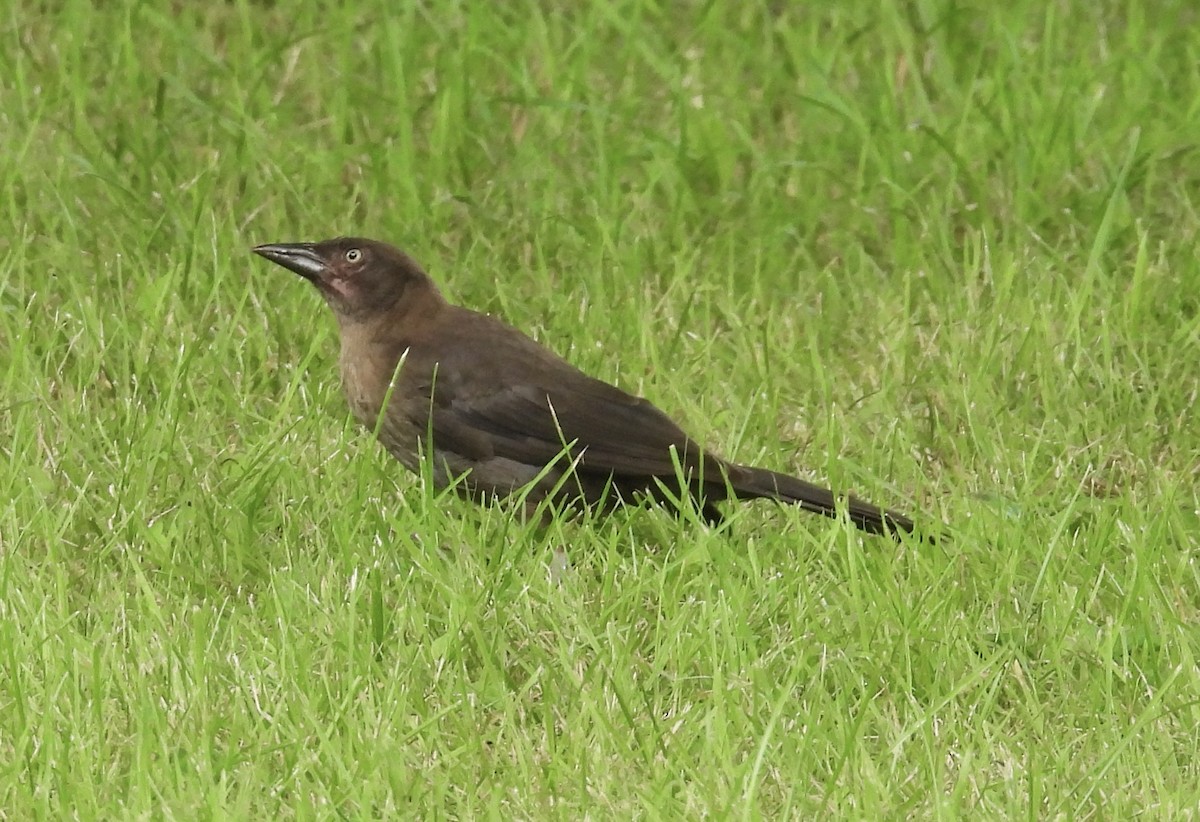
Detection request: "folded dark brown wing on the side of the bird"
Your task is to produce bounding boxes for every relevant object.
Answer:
[432,372,720,476]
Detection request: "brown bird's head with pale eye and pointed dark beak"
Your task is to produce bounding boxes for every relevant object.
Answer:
[254,236,437,322]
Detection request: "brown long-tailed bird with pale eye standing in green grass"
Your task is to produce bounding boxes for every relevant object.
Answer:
[254,238,913,534]
